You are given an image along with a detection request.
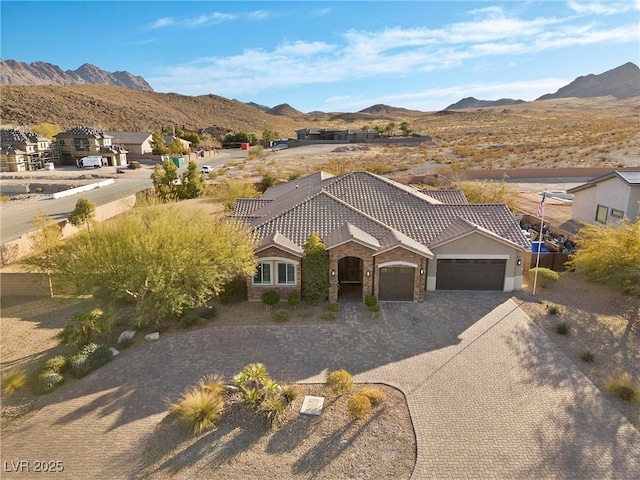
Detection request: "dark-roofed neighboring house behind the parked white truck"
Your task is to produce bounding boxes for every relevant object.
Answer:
[53,127,128,167]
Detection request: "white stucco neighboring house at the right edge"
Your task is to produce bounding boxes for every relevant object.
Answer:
[567,170,640,223]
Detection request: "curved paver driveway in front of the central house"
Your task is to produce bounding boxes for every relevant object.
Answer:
[1,292,640,479]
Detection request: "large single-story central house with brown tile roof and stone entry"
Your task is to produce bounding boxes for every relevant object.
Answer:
[232,172,531,301]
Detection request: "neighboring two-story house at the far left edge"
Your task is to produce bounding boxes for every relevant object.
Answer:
[0,128,51,172]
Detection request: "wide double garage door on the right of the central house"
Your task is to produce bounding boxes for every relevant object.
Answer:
[436,259,507,290]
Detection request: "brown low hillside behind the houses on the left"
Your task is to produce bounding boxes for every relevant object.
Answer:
[0,85,303,136]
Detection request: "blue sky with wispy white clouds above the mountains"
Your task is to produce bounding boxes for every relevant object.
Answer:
[0,0,640,112]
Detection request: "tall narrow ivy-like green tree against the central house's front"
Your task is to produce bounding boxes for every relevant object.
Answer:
[302,232,329,303]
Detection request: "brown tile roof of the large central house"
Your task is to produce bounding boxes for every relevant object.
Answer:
[234,172,531,256]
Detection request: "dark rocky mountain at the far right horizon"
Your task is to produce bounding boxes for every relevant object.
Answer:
[537,62,640,100]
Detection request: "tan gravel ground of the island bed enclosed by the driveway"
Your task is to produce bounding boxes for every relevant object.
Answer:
[139,385,415,479]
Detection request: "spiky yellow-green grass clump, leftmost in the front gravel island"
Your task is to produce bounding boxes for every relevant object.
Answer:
[171,387,224,435]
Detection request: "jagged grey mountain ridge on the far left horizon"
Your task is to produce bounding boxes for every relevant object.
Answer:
[0,59,153,91]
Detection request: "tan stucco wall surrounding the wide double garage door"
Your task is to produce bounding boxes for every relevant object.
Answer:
[427,233,525,291]
